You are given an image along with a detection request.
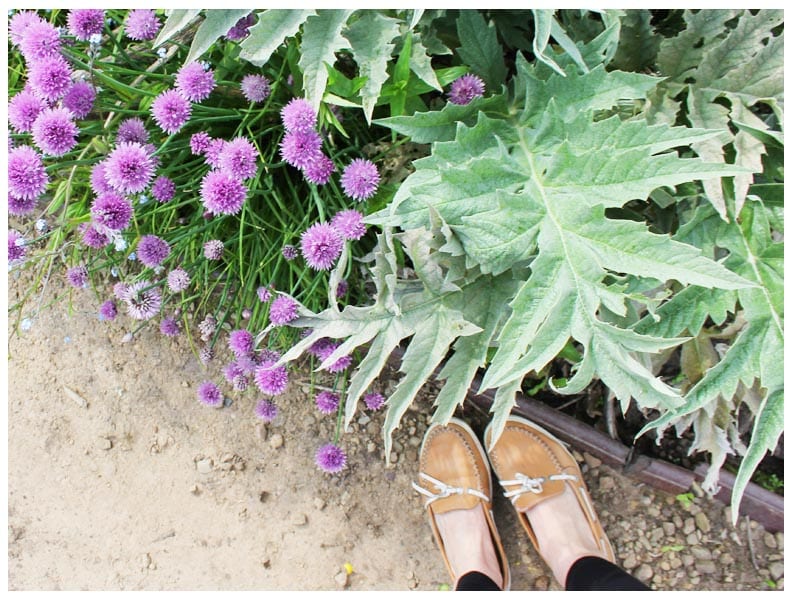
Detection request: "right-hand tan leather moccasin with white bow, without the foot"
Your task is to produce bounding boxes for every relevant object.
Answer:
[485,416,615,562]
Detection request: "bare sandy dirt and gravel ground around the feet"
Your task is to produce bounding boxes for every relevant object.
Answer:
[8,285,784,590]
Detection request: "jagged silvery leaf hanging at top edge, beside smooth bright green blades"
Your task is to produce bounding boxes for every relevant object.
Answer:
[345,11,401,123]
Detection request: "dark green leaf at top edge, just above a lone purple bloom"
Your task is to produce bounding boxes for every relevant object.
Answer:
[456,10,507,91]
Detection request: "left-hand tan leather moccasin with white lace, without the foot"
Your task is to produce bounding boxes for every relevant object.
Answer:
[412,418,510,590]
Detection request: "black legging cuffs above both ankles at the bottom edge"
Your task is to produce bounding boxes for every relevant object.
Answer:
[455,556,650,592]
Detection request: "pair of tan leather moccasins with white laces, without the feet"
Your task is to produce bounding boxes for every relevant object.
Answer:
[412,416,615,589]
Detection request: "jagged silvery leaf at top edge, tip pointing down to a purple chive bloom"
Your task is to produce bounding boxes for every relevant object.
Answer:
[299,9,353,109]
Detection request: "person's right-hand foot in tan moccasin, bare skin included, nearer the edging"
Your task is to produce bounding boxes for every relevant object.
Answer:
[485,417,615,585]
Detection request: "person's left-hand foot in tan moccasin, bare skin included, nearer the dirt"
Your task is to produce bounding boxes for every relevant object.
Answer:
[412,419,510,589]
